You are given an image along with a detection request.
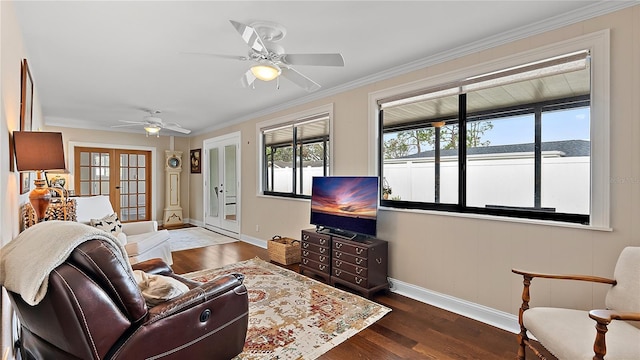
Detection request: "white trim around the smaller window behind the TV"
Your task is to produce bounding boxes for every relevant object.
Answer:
[256,103,334,200]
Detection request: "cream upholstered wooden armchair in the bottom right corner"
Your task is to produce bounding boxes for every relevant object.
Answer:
[512,247,640,360]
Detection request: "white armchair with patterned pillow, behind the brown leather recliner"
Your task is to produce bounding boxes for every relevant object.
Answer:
[75,195,173,265]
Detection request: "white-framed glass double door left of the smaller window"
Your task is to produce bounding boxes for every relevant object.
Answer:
[203,133,240,236]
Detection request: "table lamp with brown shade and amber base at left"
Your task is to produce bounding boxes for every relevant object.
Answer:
[13,131,66,222]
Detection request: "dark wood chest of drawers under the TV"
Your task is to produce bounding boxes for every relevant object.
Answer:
[300,230,389,298]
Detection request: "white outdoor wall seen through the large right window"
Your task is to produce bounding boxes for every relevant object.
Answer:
[384,156,590,214]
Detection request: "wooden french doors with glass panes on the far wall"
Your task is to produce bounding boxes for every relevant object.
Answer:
[74,147,151,222]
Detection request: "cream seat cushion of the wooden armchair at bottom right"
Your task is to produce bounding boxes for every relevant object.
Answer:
[522,307,640,360]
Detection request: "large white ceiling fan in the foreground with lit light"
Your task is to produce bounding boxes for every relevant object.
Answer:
[198,20,344,92]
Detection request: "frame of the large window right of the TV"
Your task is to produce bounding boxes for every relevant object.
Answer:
[369,29,610,230]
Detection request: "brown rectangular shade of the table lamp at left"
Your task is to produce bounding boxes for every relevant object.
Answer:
[13,131,66,171]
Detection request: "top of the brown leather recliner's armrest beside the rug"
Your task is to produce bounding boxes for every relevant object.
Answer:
[146,274,247,324]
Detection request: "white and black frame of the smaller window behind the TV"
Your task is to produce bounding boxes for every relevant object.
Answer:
[256,103,334,199]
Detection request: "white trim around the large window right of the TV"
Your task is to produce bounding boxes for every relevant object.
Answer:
[369,29,611,231]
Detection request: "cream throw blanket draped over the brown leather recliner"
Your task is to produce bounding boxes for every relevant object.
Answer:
[0,221,131,306]
